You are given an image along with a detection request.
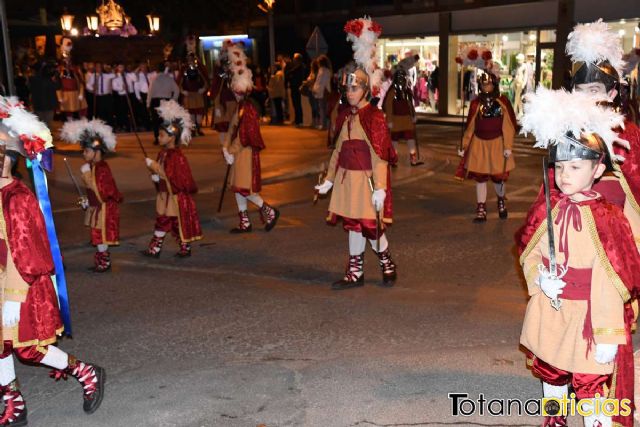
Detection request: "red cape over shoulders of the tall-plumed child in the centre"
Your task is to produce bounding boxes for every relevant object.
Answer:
[336,104,398,218]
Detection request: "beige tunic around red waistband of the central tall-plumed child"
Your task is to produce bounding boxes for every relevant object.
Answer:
[326,115,391,222]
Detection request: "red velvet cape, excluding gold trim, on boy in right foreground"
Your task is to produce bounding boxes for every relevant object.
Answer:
[515,194,640,427]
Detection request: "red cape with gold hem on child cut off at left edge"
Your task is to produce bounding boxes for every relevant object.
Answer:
[0,180,63,347]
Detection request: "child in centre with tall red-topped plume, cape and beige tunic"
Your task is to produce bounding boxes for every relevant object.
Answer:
[315,18,398,290]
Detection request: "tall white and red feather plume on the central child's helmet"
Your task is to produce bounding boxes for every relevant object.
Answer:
[344,16,384,96]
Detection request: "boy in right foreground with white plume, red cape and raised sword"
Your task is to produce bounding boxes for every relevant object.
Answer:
[516,87,640,427]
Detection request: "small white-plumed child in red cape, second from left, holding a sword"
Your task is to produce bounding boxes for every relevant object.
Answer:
[60,119,122,273]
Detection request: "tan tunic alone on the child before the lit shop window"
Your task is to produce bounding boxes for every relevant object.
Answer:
[462,103,516,175]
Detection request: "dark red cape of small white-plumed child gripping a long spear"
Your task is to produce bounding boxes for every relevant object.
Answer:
[158,148,202,242]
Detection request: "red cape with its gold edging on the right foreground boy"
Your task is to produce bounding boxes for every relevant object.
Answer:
[515,194,640,427]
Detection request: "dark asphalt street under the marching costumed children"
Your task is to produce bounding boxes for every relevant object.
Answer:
[11,125,640,427]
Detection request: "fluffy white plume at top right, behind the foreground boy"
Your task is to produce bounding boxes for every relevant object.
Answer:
[566,19,625,76]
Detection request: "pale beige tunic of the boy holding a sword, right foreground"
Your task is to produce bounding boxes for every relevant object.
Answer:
[520,206,625,375]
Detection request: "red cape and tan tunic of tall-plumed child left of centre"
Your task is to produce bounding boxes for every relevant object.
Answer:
[224,100,265,196]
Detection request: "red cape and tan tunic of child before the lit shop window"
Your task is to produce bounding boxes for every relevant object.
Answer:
[455,96,518,182]
